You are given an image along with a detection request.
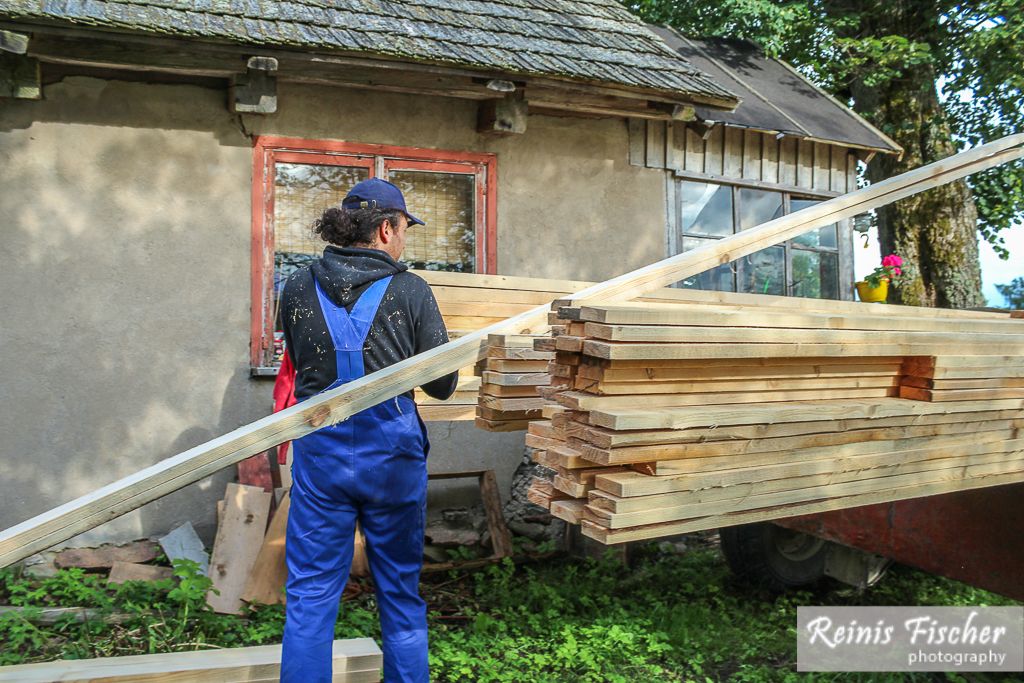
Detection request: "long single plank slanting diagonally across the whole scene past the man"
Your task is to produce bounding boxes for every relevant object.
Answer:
[0,135,1024,566]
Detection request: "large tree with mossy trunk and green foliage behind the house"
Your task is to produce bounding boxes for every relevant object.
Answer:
[624,0,1024,306]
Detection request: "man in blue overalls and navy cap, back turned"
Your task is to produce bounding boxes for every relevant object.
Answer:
[281,178,458,683]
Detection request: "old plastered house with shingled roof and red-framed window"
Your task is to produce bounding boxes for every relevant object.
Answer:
[0,0,898,540]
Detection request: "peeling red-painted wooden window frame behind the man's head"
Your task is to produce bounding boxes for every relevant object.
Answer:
[249,135,498,375]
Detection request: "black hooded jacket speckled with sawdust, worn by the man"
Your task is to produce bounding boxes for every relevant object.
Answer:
[281,246,459,399]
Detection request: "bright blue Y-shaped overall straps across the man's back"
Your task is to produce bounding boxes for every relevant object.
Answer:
[313,275,391,389]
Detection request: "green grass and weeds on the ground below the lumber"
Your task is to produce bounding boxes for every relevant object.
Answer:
[0,544,1020,683]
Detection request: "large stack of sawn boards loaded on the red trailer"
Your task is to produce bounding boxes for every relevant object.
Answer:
[526,293,1024,544]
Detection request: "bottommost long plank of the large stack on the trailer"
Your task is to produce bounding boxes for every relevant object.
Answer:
[582,472,1024,545]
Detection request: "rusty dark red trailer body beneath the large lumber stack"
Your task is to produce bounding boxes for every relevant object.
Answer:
[775,483,1024,600]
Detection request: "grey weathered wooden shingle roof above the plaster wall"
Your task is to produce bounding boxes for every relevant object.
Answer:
[0,0,736,105]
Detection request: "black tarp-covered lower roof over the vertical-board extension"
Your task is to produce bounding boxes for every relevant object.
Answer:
[651,27,901,153]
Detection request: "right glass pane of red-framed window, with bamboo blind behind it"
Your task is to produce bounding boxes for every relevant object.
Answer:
[388,171,476,272]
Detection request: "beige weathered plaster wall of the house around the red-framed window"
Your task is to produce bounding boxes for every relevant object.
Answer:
[0,77,665,543]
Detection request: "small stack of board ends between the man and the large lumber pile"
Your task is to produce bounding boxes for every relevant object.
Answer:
[476,335,554,431]
